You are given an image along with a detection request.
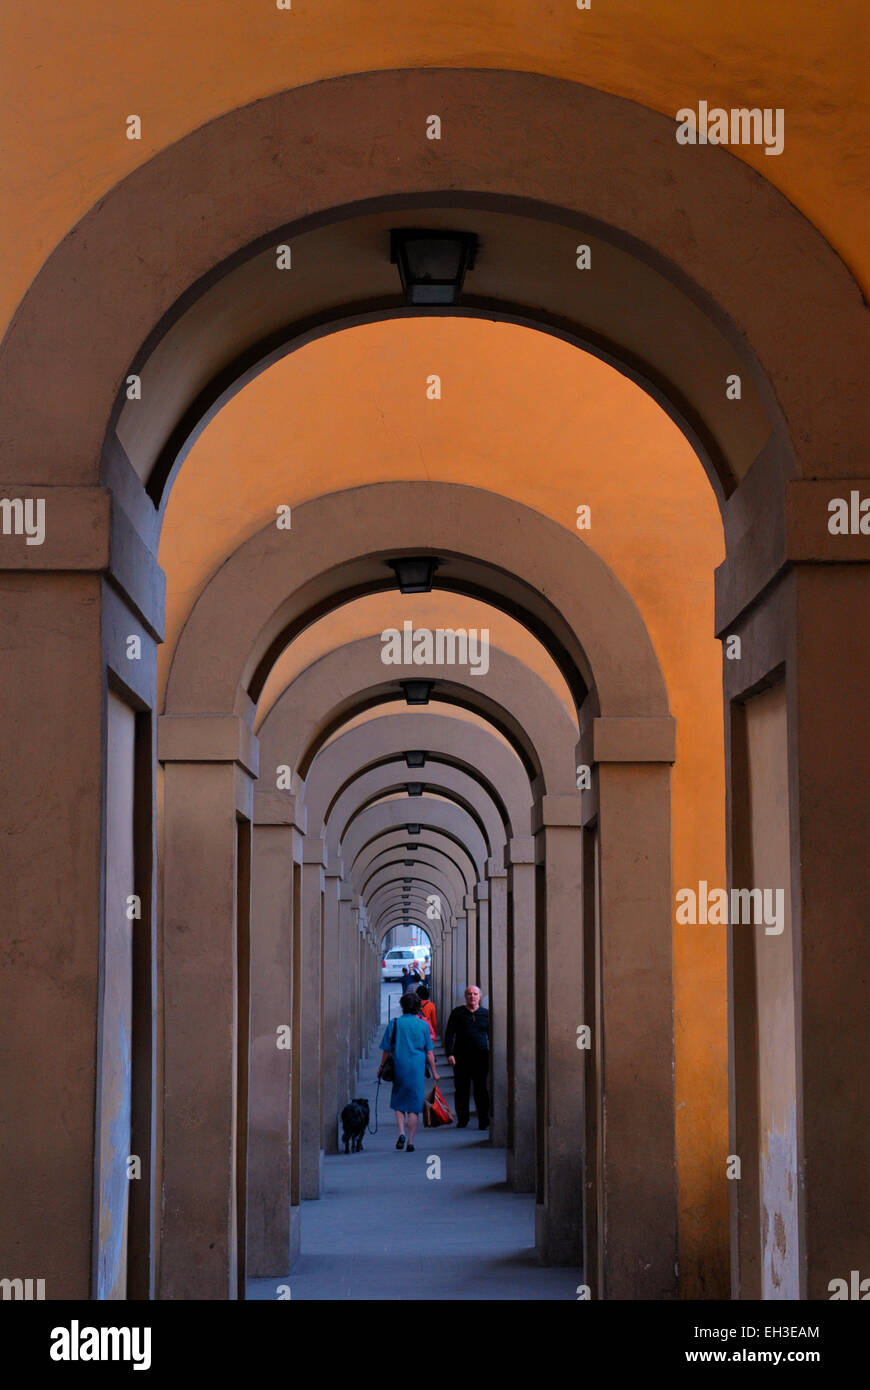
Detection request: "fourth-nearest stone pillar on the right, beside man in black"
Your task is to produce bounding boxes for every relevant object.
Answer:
[504,835,536,1193]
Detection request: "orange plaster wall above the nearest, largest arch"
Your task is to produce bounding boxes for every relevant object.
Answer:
[0,0,870,340]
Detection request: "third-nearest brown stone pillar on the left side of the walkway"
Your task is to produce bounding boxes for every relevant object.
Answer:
[247,791,302,1279]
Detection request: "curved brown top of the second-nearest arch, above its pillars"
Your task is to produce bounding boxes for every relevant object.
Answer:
[165,482,668,721]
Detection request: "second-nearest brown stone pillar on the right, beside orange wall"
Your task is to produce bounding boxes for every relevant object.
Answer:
[583,717,677,1300]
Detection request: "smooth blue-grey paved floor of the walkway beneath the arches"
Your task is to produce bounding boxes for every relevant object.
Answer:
[247,1038,581,1301]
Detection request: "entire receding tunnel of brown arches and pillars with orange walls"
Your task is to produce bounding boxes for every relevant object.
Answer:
[0,38,870,1301]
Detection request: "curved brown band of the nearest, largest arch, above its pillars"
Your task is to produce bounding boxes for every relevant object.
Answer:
[0,70,867,505]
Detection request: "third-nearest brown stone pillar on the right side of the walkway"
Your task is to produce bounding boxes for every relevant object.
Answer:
[532,795,583,1265]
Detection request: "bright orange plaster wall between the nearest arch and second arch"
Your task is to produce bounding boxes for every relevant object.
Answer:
[160,318,727,1297]
